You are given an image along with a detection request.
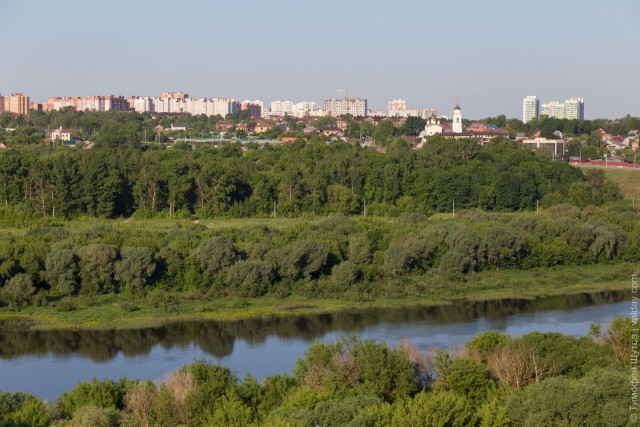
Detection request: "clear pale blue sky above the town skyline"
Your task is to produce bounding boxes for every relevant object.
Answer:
[0,0,640,118]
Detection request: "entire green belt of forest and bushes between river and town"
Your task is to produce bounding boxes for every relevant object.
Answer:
[0,115,640,327]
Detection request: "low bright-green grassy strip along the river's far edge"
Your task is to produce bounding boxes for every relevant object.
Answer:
[0,263,635,330]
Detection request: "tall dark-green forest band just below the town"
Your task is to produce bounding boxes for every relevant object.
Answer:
[0,132,620,225]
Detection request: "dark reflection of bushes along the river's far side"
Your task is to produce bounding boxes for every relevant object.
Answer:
[0,291,630,361]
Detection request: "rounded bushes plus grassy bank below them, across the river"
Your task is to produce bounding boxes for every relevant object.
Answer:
[0,204,640,326]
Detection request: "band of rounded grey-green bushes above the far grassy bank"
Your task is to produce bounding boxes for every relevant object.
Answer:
[0,204,640,310]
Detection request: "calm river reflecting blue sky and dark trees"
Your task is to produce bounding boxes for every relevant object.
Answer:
[0,291,630,400]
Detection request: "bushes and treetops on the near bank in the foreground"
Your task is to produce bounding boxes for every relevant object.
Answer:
[0,318,635,427]
